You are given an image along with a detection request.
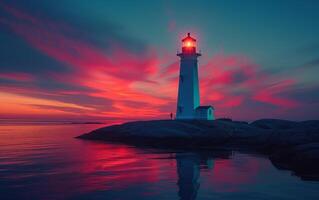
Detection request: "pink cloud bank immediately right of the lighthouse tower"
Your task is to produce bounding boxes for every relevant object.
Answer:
[199,54,300,118]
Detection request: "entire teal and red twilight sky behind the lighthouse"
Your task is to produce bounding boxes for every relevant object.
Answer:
[0,0,319,120]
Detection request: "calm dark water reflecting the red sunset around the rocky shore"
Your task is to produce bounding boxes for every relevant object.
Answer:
[0,124,319,200]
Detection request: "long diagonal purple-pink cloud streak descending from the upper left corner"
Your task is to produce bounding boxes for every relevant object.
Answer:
[2,3,157,80]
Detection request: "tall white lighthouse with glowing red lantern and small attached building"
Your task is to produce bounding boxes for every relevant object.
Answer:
[176,33,214,120]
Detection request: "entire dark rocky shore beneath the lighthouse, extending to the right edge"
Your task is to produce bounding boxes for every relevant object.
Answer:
[78,119,319,179]
